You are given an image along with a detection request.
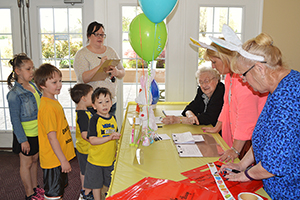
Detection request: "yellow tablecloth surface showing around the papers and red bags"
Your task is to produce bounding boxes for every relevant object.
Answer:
[109,102,271,199]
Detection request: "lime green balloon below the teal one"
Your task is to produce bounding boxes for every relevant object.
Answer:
[128,13,168,61]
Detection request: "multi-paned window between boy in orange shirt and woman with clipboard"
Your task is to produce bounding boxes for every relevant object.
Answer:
[39,7,83,131]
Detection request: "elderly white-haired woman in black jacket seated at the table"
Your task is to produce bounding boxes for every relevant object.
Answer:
[162,67,225,126]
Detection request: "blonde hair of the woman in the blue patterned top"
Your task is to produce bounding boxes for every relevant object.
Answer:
[231,33,287,74]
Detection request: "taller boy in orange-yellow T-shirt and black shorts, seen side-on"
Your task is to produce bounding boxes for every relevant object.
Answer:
[34,64,75,199]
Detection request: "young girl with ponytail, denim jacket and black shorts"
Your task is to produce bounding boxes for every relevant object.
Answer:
[7,53,44,200]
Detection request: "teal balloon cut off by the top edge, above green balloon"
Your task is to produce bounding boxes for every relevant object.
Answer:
[139,0,177,24]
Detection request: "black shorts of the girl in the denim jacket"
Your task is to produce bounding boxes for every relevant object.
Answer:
[13,134,39,156]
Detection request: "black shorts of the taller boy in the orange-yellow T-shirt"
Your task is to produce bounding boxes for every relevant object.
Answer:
[43,166,68,197]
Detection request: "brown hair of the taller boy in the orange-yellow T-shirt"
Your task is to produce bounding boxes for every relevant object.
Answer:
[34,63,62,90]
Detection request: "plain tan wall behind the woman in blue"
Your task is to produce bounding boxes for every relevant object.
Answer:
[262,0,300,71]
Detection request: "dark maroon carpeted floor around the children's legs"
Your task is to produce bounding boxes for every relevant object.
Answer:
[0,150,81,200]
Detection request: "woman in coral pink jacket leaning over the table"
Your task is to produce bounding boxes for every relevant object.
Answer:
[197,39,267,162]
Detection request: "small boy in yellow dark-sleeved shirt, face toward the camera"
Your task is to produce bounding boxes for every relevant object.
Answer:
[84,87,121,200]
